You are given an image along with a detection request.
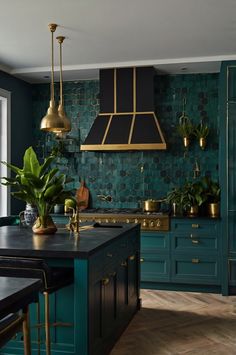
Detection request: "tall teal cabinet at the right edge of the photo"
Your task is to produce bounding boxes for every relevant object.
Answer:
[220,62,236,294]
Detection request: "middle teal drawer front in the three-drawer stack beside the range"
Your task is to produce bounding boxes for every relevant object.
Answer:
[171,233,219,254]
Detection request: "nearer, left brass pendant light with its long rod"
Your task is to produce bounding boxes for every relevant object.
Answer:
[40,23,68,133]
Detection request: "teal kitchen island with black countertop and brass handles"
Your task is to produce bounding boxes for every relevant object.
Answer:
[0,223,140,355]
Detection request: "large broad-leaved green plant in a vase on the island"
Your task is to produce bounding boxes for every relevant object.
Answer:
[2,147,71,234]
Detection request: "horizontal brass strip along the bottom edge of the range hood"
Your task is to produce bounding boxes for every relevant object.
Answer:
[80,143,166,150]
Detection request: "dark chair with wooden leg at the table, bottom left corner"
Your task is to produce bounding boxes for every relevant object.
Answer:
[0,307,31,355]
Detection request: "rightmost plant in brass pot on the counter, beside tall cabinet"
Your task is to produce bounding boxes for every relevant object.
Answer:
[202,177,220,218]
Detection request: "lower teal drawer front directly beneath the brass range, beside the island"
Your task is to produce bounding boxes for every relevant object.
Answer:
[140,253,170,282]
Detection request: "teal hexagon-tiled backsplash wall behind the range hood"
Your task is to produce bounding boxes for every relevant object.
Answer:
[33,74,219,208]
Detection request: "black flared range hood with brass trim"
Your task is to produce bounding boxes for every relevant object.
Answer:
[81,67,166,151]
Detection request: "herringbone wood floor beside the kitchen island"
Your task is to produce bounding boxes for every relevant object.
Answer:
[110,290,236,355]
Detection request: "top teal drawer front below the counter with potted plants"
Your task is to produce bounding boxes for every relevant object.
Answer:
[171,219,219,235]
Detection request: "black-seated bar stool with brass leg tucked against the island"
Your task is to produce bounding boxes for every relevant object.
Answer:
[0,256,74,355]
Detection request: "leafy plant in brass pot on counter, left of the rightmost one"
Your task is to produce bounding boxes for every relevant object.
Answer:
[182,181,207,216]
